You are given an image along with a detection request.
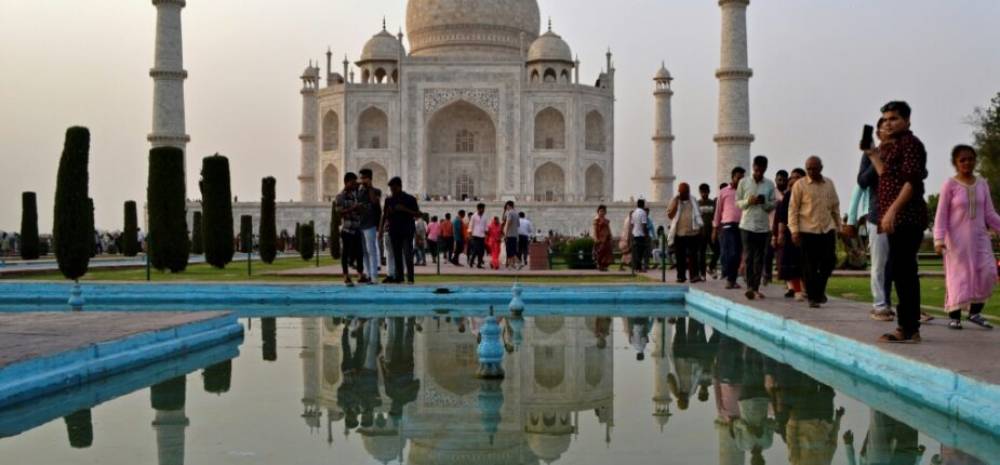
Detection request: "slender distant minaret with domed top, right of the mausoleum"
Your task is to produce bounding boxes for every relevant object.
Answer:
[651,64,675,202]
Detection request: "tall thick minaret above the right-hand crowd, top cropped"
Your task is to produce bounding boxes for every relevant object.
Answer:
[715,0,754,183]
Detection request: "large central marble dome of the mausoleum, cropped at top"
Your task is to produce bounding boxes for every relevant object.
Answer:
[406,0,541,58]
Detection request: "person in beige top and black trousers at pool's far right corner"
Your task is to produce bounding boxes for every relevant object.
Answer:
[667,182,702,283]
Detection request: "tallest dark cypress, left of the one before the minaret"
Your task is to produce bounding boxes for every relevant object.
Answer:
[52,126,94,280]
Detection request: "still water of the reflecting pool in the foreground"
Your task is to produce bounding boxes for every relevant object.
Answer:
[0,307,1000,465]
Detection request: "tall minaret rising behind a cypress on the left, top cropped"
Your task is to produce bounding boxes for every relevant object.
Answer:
[146,0,191,155]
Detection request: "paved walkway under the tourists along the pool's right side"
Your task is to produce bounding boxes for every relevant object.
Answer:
[692,280,1000,384]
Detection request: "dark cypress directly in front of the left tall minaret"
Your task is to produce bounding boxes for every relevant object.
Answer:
[146,147,191,273]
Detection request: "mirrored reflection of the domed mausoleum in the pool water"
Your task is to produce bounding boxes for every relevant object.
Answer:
[301,317,614,465]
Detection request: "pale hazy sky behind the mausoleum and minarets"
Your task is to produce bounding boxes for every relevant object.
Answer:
[0,0,1000,231]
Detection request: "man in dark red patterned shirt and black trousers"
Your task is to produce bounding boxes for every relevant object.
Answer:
[868,102,928,343]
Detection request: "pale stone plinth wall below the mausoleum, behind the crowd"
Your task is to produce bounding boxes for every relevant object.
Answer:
[188,201,666,237]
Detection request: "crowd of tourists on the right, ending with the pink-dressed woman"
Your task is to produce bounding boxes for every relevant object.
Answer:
[608,101,1000,343]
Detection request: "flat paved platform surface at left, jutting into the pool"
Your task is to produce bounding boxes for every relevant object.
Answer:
[0,312,225,368]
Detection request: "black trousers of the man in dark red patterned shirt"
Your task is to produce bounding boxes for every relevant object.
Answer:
[889,226,924,336]
